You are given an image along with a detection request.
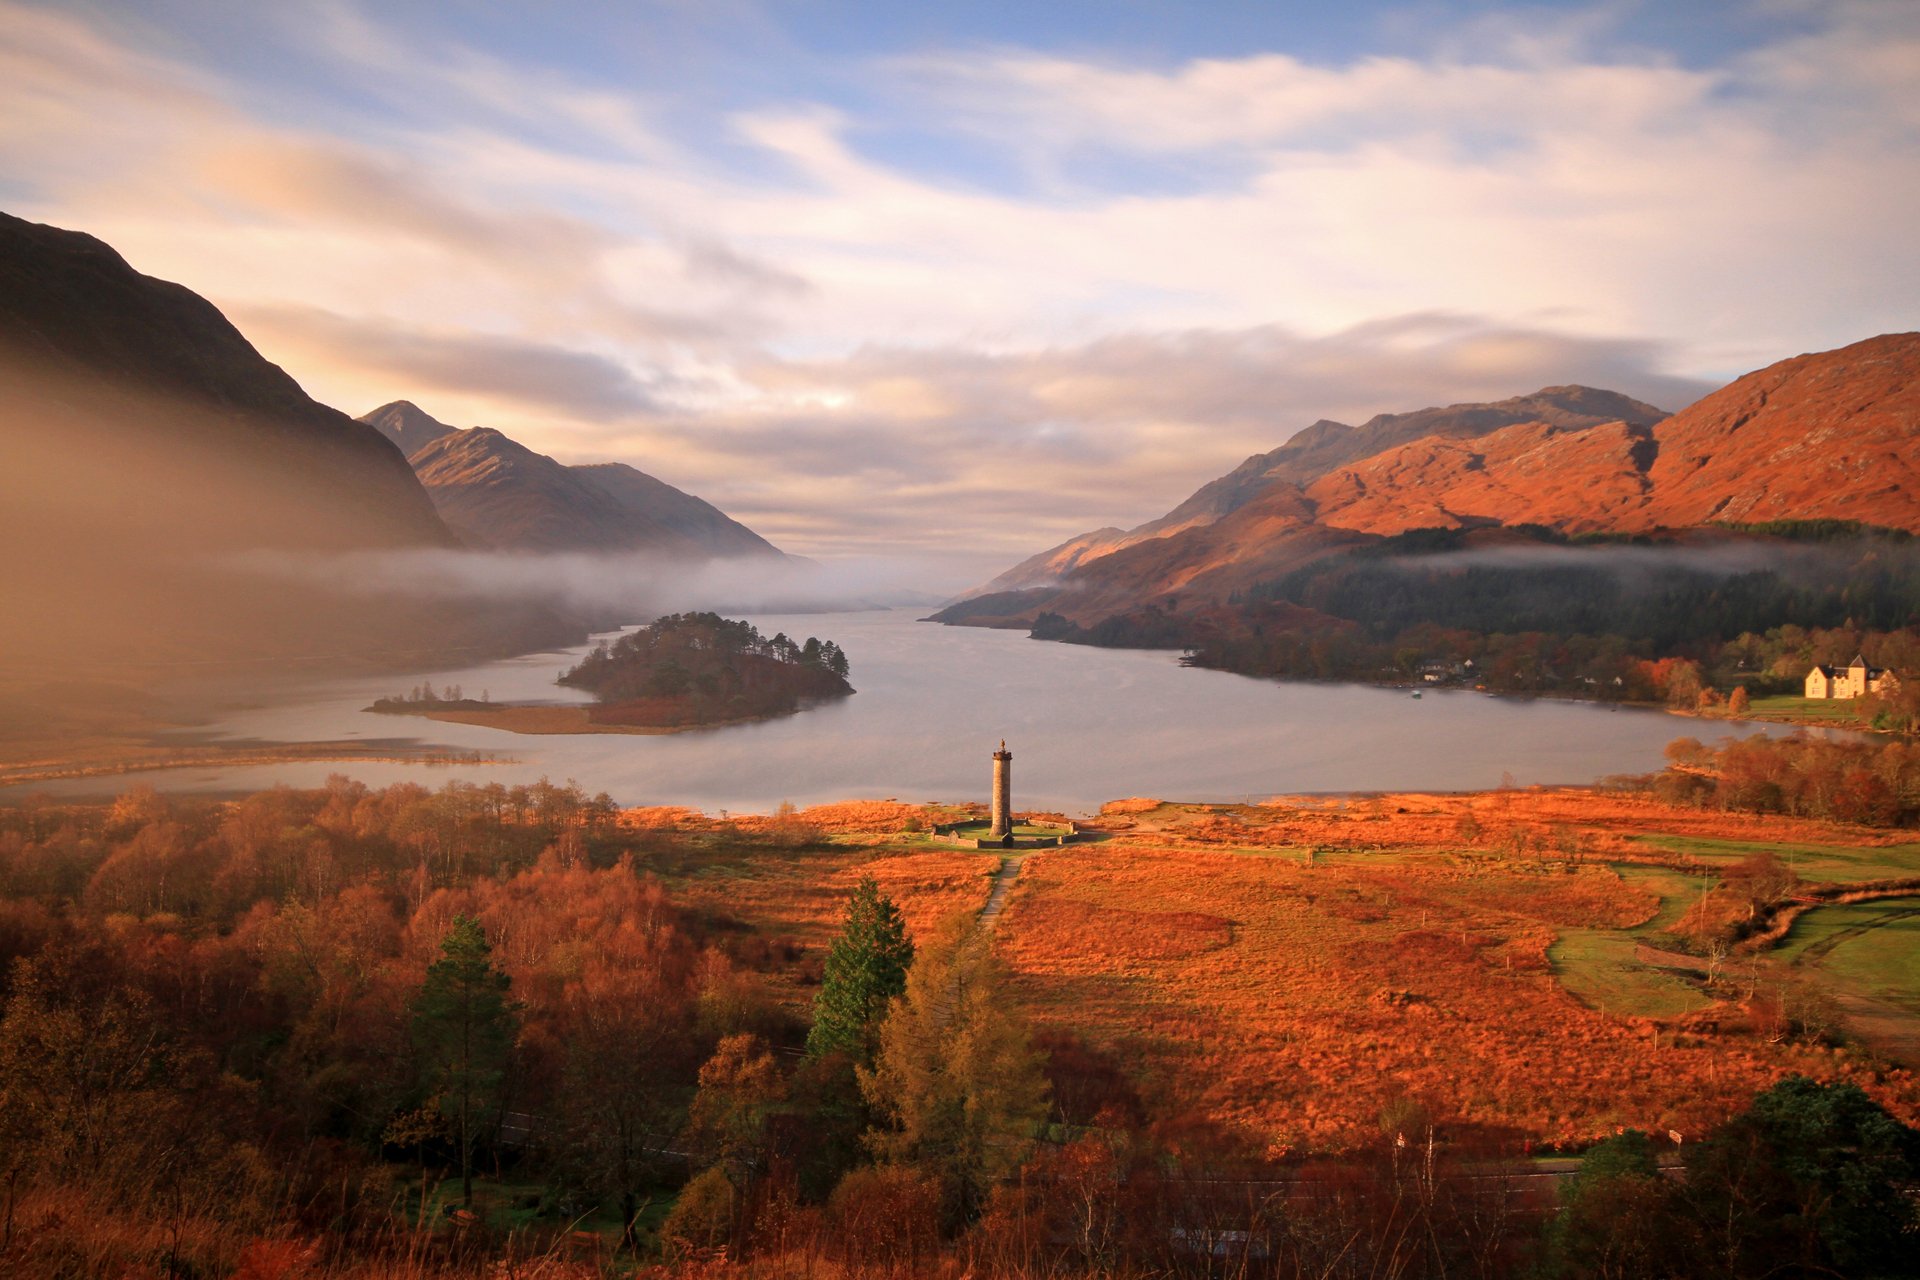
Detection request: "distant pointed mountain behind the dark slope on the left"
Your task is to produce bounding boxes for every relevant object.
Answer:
[361,401,780,557]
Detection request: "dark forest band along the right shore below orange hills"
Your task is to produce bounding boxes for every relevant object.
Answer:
[1033,520,1920,706]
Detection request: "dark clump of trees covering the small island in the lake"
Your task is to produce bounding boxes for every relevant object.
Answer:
[559,612,852,727]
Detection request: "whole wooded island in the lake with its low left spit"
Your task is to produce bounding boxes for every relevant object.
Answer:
[367,612,854,733]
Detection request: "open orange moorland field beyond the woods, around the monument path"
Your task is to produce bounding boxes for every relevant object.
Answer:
[637,789,1920,1151]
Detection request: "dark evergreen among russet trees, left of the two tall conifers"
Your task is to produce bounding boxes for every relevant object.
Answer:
[413,915,518,1207]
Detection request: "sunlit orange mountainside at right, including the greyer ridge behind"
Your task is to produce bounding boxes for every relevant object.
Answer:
[939,334,1920,626]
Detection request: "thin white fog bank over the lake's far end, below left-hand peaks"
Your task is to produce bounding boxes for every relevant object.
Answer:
[221,549,962,622]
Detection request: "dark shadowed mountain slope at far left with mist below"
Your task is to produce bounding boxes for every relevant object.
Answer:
[0,213,451,547]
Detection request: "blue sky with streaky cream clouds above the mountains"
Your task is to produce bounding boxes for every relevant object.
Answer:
[0,0,1920,587]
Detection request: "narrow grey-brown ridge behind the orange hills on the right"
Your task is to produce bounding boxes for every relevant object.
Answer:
[981,386,1667,593]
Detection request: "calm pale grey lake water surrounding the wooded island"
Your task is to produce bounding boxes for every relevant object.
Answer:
[15,610,1761,814]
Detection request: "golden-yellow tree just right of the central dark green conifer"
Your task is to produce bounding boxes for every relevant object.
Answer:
[860,917,1048,1219]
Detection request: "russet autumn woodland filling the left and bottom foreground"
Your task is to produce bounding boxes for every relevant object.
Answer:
[0,777,1920,1280]
